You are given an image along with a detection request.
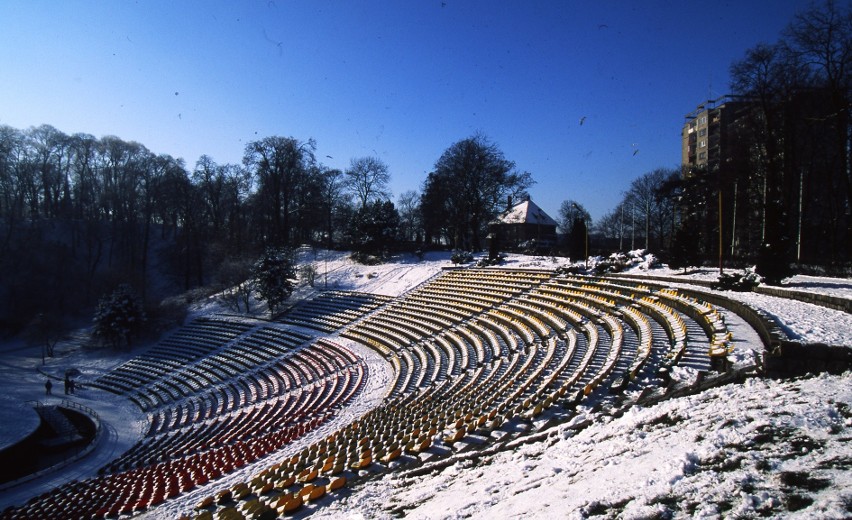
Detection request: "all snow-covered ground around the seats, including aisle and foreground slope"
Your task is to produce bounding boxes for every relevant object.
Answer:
[0,251,852,518]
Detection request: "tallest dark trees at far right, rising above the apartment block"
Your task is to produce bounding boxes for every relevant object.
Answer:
[682,1,852,265]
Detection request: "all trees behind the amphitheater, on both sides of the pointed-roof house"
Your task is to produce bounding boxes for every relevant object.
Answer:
[0,1,852,338]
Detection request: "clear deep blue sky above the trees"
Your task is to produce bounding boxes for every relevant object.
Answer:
[0,0,810,219]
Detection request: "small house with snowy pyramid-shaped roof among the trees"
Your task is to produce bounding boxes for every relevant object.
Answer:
[489,197,557,252]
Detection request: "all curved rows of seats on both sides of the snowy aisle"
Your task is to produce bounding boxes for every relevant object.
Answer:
[1,269,731,518]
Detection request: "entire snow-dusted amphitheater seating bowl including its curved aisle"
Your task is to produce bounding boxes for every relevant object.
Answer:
[0,251,852,519]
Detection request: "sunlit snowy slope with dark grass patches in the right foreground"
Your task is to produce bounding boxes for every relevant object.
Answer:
[312,373,852,519]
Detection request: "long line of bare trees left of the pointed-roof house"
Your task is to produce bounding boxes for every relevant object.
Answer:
[0,125,532,338]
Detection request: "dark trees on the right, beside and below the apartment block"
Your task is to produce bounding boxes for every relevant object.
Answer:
[584,0,852,269]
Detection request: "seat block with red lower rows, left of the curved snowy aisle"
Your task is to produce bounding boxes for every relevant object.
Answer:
[3,320,367,518]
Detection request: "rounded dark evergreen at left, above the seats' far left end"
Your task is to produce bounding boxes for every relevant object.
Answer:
[93,284,146,348]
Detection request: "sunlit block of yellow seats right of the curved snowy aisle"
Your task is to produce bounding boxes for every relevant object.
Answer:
[193,269,729,518]
